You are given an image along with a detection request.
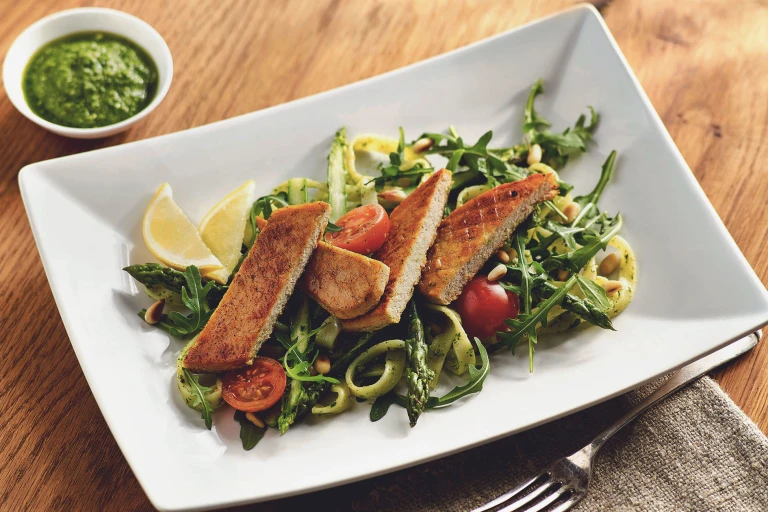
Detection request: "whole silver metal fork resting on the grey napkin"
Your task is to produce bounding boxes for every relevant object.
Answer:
[472,330,760,512]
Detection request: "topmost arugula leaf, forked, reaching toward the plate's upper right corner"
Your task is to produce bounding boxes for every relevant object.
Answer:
[523,79,599,169]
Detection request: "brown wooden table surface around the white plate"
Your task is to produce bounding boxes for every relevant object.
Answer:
[0,0,768,510]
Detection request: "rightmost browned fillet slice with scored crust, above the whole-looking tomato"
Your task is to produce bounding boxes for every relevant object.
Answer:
[419,174,558,304]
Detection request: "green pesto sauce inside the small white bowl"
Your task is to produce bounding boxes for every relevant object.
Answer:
[22,32,157,128]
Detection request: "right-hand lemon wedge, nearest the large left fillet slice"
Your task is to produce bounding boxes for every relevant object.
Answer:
[198,180,256,284]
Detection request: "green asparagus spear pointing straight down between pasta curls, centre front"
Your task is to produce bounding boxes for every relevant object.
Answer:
[405,300,434,427]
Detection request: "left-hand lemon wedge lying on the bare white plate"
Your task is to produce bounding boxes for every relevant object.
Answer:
[142,183,224,274]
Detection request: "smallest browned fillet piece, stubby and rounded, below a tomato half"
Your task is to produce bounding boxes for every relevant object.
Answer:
[302,242,389,319]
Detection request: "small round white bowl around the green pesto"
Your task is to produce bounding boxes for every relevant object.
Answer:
[3,7,173,139]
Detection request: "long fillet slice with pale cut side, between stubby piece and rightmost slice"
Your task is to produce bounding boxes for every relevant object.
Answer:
[342,169,451,332]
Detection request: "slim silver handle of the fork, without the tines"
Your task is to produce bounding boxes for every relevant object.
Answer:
[583,330,761,458]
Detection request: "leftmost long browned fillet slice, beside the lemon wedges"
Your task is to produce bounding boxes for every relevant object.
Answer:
[184,202,331,373]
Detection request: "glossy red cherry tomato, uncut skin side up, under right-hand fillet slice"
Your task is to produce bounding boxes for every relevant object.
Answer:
[455,275,520,340]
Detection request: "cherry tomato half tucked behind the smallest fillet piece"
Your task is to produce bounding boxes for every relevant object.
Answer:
[325,204,389,254]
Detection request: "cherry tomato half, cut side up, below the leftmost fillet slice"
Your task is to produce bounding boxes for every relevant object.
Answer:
[221,356,286,412]
